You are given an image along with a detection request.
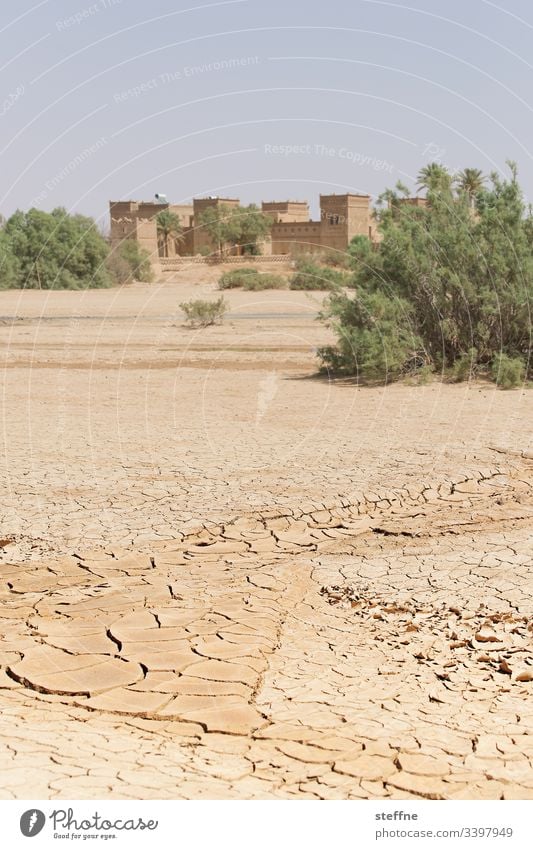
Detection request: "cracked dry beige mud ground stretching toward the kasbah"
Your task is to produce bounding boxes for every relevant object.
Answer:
[0,272,533,799]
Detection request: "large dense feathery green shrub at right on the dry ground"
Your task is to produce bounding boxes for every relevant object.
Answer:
[321,164,533,379]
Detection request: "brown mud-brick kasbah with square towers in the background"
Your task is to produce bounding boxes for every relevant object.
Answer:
[109,193,378,270]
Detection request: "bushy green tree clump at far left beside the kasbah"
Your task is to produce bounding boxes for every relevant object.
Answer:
[2,208,112,289]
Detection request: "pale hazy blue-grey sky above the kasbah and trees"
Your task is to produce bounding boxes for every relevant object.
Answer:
[0,0,533,227]
